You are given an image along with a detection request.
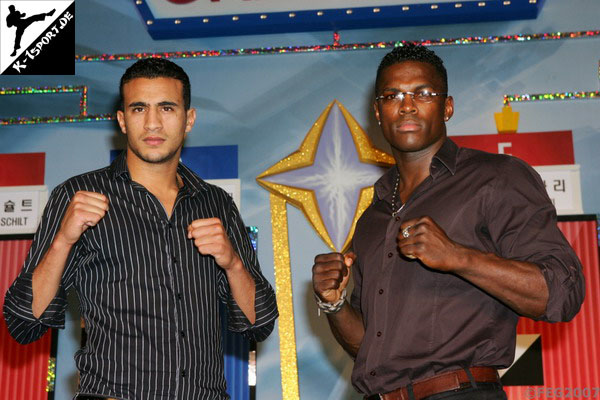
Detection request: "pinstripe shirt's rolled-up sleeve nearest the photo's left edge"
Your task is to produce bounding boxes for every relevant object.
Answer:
[3,187,79,344]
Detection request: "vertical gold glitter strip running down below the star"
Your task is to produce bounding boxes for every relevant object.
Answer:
[269,194,300,400]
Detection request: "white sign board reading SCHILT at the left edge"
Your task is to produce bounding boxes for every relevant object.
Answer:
[0,185,48,235]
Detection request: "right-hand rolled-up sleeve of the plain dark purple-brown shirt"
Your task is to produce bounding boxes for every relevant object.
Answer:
[487,158,585,322]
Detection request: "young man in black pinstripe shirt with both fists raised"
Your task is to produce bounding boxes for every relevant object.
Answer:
[4,59,277,400]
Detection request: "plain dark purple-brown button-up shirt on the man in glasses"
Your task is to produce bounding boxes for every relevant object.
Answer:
[351,140,585,394]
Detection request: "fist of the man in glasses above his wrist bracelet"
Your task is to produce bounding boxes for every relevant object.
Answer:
[313,251,356,303]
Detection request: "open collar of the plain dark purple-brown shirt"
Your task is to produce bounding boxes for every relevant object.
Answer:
[374,138,459,201]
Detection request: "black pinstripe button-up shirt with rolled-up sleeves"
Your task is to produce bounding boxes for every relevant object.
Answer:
[4,154,277,400]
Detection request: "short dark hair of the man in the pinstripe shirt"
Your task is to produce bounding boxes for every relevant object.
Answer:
[119,58,191,110]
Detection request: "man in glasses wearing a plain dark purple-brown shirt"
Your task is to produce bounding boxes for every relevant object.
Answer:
[313,45,584,400]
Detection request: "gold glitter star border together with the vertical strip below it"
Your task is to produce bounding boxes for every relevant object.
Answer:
[256,100,394,400]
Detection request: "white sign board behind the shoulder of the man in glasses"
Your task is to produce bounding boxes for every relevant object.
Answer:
[533,164,583,215]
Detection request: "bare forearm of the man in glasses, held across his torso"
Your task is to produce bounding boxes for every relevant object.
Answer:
[453,247,548,318]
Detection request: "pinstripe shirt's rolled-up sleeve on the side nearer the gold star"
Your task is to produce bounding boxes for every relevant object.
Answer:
[219,195,279,342]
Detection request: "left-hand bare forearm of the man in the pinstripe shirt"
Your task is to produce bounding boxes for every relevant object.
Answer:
[31,237,72,318]
